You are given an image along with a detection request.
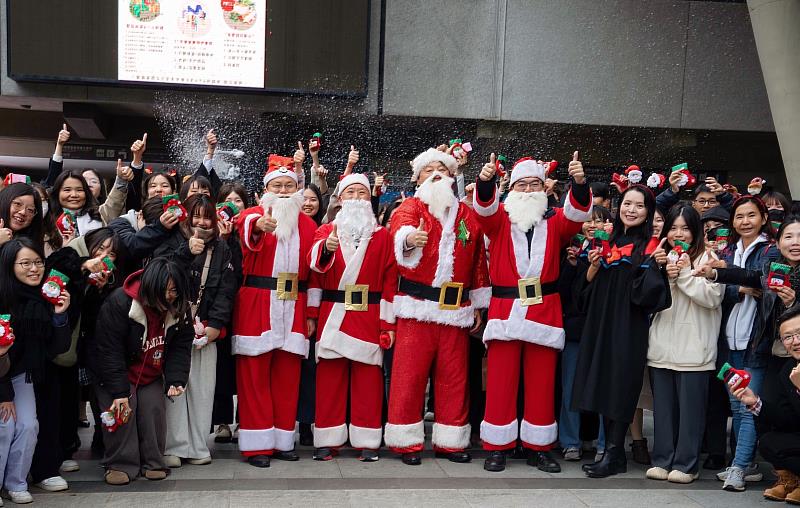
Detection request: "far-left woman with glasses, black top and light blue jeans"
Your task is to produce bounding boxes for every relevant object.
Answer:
[0,236,70,503]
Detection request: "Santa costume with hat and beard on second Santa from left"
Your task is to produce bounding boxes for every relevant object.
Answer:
[309,173,397,461]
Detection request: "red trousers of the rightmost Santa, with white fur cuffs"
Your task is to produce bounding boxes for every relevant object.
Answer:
[481,340,558,451]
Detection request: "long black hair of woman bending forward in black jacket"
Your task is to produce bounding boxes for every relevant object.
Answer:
[138,257,190,319]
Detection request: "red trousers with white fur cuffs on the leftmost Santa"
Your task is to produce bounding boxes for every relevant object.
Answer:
[236,349,302,457]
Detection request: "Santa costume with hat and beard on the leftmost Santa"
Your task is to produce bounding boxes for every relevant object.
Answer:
[232,155,316,467]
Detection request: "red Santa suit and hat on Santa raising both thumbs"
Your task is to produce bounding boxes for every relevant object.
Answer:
[474,160,592,451]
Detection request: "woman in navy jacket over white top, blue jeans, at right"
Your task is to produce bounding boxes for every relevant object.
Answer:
[701,196,779,491]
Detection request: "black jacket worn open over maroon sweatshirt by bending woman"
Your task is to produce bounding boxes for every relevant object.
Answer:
[89,272,194,399]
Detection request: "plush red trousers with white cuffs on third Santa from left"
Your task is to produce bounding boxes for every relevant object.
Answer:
[384,318,470,453]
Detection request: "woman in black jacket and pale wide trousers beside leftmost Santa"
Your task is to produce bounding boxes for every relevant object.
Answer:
[154,194,238,467]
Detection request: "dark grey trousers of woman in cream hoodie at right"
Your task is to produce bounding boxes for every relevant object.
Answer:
[650,367,710,474]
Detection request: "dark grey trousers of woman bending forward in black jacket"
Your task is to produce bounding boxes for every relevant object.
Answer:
[95,379,167,480]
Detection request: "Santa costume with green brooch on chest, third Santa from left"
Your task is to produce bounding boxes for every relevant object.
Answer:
[384,149,490,464]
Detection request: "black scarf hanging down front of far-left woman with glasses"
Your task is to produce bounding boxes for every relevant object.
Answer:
[11,283,53,383]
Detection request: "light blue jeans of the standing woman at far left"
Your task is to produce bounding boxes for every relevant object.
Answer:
[0,372,39,492]
